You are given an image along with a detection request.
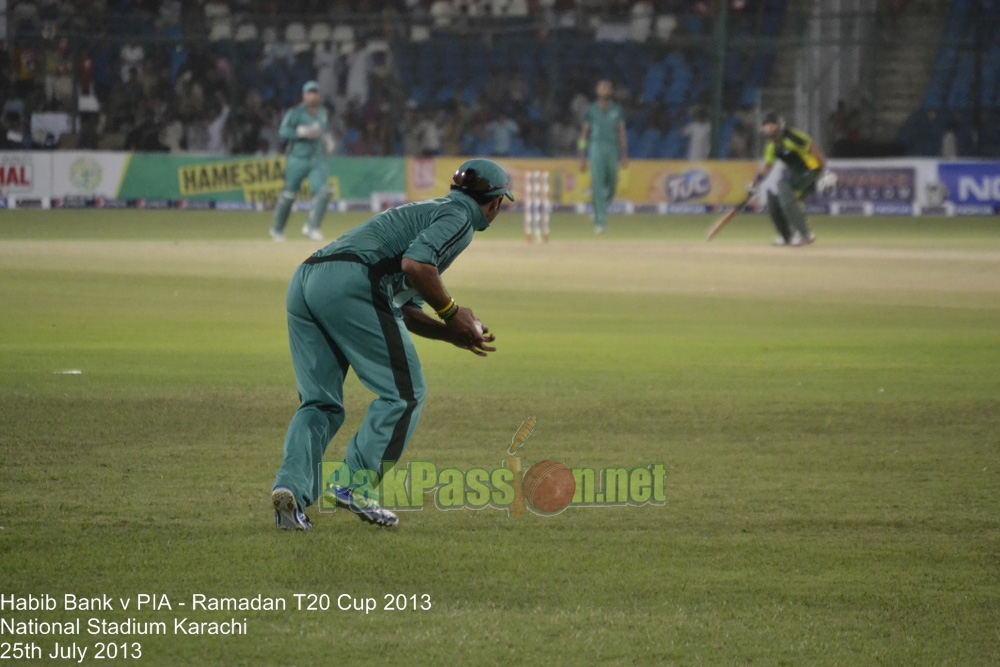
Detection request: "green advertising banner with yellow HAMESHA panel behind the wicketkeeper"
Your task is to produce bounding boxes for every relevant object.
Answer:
[118,153,406,206]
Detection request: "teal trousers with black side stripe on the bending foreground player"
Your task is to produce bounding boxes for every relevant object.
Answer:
[274,255,426,509]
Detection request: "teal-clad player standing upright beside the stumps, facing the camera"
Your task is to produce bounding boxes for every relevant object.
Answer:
[577,79,628,234]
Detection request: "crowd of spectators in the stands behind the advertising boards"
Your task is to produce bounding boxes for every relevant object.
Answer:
[0,0,768,159]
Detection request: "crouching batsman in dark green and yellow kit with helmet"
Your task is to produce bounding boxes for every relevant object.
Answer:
[751,111,833,246]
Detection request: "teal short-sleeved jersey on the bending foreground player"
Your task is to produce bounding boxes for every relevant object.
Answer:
[313,191,490,308]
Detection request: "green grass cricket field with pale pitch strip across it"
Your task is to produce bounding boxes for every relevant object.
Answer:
[0,211,1000,666]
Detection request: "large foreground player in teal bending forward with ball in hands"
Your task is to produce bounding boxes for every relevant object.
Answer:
[271,159,513,530]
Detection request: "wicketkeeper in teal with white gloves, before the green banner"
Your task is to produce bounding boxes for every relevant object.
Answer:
[271,81,334,241]
